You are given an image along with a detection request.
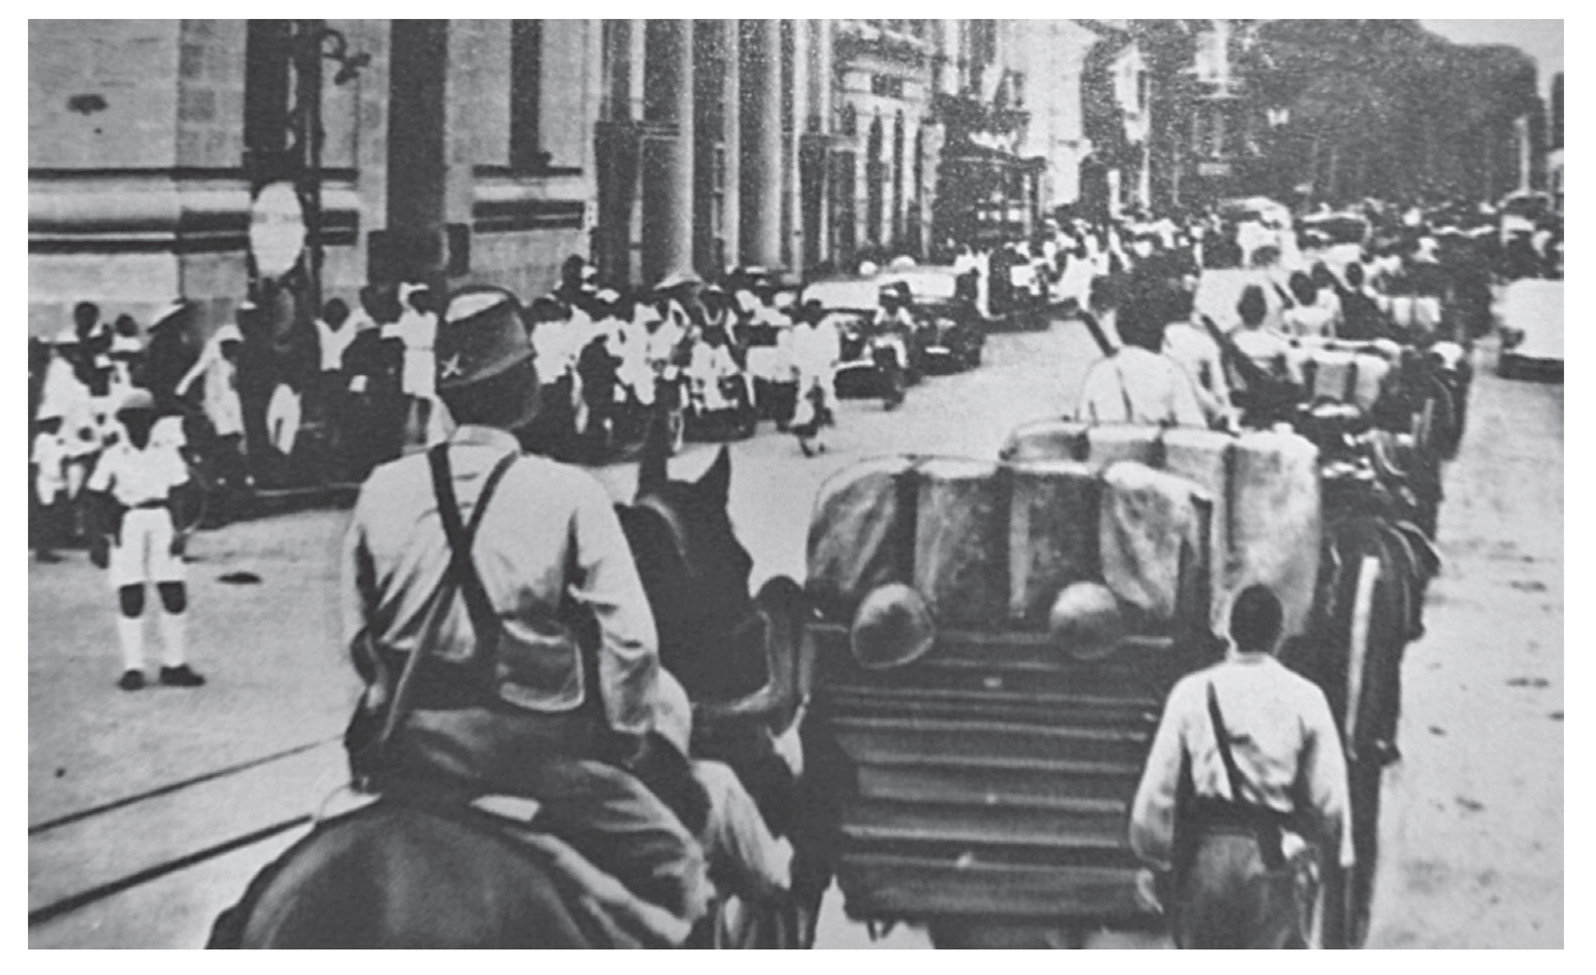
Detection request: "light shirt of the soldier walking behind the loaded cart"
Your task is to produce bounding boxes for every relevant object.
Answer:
[1130,654,1353,866]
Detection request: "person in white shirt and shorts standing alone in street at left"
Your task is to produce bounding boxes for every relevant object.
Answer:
[86,389,204,691]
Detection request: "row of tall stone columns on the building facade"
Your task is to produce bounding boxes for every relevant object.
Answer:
[632,19,832,281]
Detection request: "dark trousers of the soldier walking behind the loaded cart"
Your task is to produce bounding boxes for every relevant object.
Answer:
[1170,828,1307,948]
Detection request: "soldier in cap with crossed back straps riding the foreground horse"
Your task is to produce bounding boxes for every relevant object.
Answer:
[343,287,702,931]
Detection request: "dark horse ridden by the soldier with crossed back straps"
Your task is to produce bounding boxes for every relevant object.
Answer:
[209,423,798,948]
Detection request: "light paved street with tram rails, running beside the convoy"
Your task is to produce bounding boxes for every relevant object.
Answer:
[29,322,1564,946]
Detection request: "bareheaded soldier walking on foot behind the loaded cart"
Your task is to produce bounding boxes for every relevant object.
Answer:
[1130,586,1352,948]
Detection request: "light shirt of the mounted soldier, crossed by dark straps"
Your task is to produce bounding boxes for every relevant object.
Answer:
[343,424,659,734]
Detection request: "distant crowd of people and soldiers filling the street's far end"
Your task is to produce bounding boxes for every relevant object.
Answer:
[1040,192,1538,428]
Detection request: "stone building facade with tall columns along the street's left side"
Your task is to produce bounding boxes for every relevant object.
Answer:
[29,19,1079,343]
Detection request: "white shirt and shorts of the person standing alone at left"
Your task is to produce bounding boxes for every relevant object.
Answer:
[86,437,188,589]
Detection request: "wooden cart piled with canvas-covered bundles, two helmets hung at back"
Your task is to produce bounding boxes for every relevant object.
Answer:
[806,456,1213,922]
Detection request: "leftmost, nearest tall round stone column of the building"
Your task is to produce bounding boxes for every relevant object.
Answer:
[643,21,693,284]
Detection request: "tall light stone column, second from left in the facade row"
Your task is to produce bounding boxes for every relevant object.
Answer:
[741,21,782,266]
